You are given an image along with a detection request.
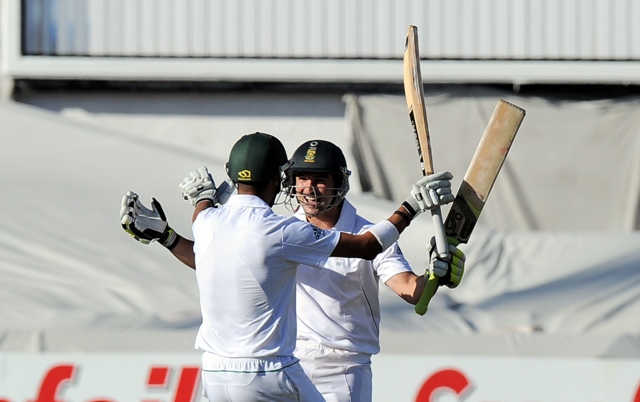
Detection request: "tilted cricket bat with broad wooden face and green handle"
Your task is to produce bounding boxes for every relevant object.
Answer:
[415,99,525,315]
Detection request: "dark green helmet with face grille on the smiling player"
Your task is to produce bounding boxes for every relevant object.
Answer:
[283,140,351,215]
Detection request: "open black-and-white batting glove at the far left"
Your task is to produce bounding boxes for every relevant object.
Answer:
[120,191,178,249]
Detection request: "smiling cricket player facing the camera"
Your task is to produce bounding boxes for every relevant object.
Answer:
[284,140,465,402]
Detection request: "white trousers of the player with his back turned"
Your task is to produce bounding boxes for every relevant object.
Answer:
[202,352,324,402]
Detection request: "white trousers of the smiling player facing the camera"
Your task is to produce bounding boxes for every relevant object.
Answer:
[293,340,373,402]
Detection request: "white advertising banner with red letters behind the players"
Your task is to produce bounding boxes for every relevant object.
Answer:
[0,352,640,402]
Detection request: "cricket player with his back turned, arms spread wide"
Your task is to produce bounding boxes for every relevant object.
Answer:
[121,133,453,401]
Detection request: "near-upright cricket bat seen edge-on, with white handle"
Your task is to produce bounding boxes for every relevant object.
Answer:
[404,25,449,258]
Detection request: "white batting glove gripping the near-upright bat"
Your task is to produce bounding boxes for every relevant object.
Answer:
[402,172,455,219]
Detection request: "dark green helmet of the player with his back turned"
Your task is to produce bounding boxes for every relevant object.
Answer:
[227,133,287,184]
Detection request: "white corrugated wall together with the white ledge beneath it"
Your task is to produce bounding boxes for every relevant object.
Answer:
[5,0,640,85]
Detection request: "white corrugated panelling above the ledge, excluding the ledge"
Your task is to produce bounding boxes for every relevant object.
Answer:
[24,0,640,60]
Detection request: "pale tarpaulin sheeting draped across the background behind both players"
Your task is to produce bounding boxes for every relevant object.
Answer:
[0,93,640,357]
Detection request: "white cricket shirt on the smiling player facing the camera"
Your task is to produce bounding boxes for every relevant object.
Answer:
[296,199,411,355]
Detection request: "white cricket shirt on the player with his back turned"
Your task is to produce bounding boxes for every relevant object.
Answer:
[193,195,340,358]
